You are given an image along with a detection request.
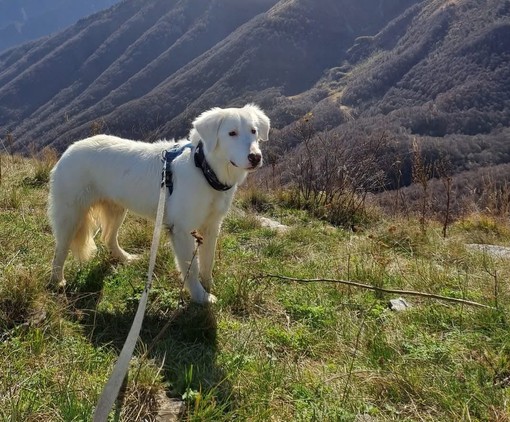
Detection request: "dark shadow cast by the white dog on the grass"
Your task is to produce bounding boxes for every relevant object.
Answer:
[68,263,232,411]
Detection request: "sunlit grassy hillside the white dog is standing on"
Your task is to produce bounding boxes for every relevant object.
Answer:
[0,154,510,421]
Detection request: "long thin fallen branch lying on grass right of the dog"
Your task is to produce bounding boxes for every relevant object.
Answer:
[259,274,496,309]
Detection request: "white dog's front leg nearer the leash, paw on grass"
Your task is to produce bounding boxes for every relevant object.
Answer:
[172,229,216,303]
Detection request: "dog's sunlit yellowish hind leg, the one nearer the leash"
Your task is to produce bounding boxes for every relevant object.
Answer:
[94,201,138,262]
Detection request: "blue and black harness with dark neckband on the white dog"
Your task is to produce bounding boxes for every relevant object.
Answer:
[161,141,232,196]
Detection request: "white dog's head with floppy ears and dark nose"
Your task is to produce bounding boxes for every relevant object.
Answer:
[193,104,270,171]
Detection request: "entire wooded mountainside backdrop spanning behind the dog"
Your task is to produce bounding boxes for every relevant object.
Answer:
[0,0,510,195]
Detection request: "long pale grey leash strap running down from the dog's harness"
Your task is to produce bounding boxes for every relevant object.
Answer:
[93,155,169,422]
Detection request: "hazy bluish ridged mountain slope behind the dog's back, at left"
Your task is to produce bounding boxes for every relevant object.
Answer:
[0,0,415,149]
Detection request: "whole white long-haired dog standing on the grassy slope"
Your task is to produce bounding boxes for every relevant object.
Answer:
[48,104,270,303]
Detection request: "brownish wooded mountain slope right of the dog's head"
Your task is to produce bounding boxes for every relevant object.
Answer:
[260,0,510,187]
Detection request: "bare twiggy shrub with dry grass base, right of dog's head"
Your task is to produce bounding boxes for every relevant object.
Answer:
[287,114,388,226]
